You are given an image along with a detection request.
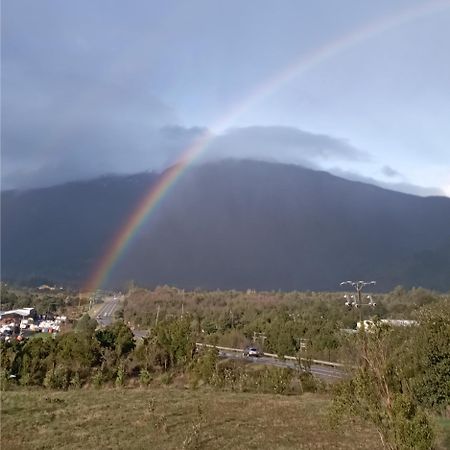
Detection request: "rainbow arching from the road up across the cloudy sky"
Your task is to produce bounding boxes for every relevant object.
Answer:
[83,0,450,292]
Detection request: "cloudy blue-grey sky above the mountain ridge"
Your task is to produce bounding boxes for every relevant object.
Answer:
[1,0,450,196]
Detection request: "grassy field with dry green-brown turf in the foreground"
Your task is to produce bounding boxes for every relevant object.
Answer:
[1,386,381,450]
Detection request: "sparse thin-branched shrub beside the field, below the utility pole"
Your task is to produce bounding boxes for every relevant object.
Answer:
[331,324,433,450]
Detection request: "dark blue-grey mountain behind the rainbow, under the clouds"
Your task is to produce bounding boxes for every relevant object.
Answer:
[2,160,450,291]
